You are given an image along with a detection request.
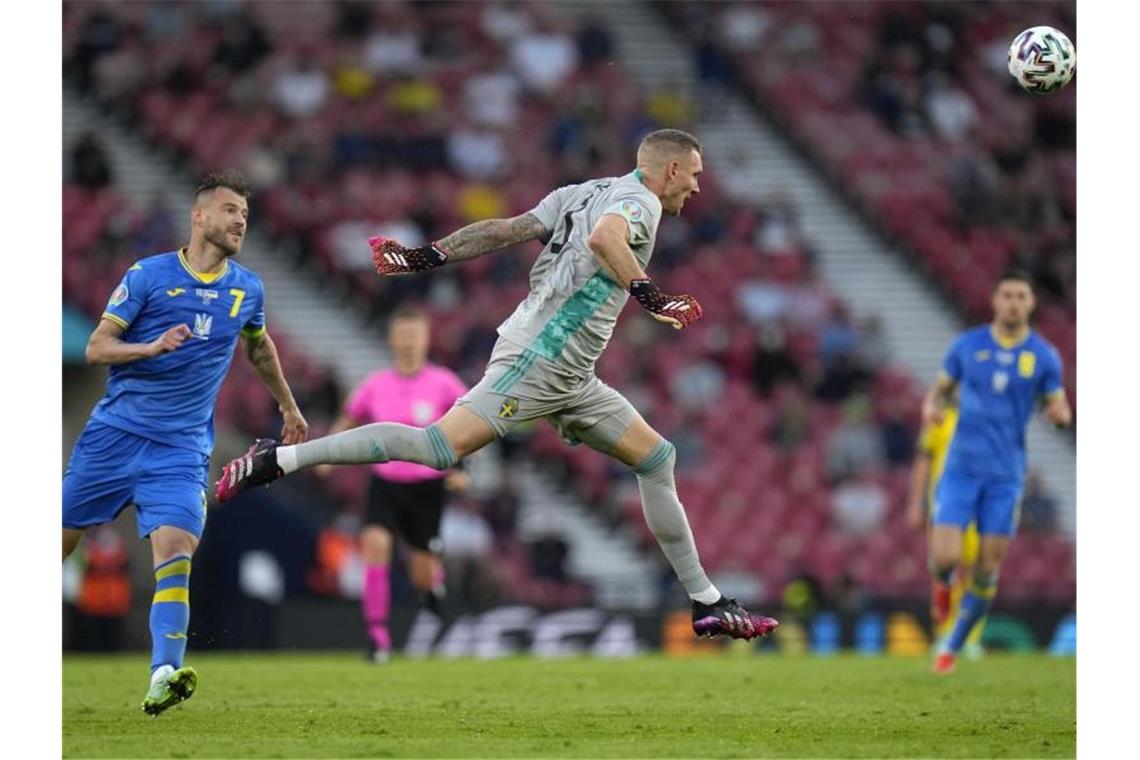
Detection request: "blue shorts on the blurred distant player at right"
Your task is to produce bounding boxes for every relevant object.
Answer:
[934,473,1021,538]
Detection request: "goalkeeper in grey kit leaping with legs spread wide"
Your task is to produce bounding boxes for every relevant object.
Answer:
[217,129,777,639]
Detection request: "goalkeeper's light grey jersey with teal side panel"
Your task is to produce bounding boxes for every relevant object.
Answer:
[498,170,661,377]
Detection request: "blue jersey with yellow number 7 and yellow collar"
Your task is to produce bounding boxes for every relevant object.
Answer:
[91,251,266,455]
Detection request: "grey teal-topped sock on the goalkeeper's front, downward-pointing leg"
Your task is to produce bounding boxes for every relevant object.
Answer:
[633,441,720,604]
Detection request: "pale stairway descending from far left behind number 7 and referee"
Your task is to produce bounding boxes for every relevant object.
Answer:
[63,90,657,607]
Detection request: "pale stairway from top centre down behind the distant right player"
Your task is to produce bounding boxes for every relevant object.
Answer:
[557,2,1076,538]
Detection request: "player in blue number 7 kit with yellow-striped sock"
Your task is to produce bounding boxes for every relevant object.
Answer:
[63,174,309,716]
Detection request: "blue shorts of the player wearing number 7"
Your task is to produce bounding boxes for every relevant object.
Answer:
[64,420,210,538]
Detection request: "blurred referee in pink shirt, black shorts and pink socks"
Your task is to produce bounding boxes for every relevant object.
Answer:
[317,307,467,663]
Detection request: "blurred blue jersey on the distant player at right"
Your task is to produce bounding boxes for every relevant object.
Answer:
[943,325,1064,482]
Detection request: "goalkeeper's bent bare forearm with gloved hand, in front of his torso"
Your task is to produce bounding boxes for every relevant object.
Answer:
[587,213,702,329]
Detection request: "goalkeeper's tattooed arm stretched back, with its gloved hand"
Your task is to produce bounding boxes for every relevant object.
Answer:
[368,212,549,275]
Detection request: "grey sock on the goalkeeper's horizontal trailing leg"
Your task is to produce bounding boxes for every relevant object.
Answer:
[277,423,457,474]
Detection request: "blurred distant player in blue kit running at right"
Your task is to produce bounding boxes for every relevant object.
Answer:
[922,270,1073,673]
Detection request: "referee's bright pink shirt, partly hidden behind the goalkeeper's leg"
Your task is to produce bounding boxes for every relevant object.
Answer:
[344,363,467,483]
